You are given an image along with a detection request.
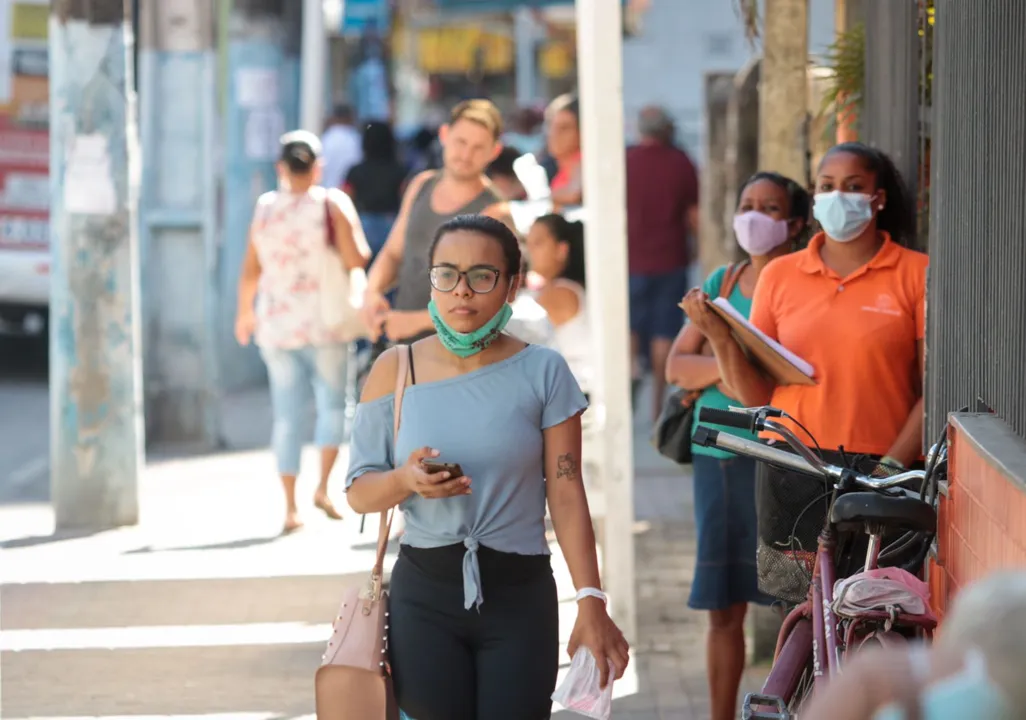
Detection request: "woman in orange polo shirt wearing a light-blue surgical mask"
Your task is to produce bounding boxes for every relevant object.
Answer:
[684,143,928,600]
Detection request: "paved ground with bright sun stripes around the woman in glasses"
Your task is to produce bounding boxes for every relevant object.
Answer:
[0,349,759,720]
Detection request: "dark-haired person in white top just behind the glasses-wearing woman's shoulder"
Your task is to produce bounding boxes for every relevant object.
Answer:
[526,214,595,393]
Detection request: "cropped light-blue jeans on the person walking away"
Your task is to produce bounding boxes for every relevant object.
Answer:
[261,344,348,475]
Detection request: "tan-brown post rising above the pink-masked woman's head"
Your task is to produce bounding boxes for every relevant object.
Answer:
[759,0,808,183]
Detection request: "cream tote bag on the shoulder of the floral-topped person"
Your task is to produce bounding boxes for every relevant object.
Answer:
[320,190,368,342]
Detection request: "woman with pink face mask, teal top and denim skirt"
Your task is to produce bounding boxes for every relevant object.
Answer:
[666,172,810,720]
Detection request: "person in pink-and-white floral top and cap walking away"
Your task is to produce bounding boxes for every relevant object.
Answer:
[235,130,370,533]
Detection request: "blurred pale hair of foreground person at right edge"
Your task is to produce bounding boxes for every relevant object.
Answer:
[937,569,1026,708]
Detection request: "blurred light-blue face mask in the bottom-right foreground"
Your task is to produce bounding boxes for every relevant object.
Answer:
[873,649,1014,720]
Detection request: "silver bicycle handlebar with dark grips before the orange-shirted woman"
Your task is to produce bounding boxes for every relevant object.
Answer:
[694,407,925,490]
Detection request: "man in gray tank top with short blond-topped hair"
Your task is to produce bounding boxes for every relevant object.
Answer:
[363,99,513,343]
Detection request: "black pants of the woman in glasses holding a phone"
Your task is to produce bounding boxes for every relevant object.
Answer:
[389,545,559,720]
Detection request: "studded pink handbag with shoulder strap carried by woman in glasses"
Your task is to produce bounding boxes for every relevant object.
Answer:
[314,346,409,720]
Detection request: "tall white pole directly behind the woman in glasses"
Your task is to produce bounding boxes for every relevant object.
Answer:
[577,0,637,638]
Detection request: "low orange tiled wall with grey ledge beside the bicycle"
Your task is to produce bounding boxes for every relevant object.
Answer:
[928,413,1026,617]
